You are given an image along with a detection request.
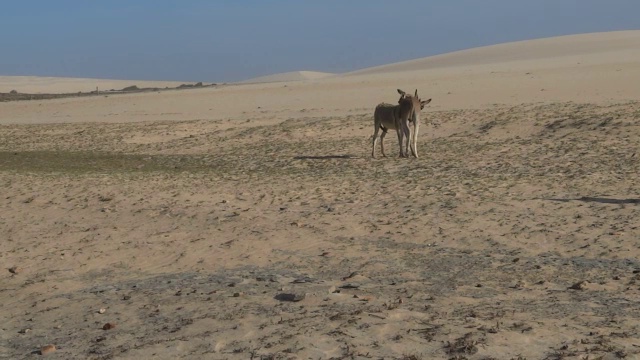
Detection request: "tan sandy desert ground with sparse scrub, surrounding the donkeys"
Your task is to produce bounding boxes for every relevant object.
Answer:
[0,31,640,359]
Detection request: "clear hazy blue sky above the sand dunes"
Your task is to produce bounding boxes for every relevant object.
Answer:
[0,0,640,83]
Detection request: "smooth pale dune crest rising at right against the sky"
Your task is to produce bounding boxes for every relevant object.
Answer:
[343,30,640,75]
